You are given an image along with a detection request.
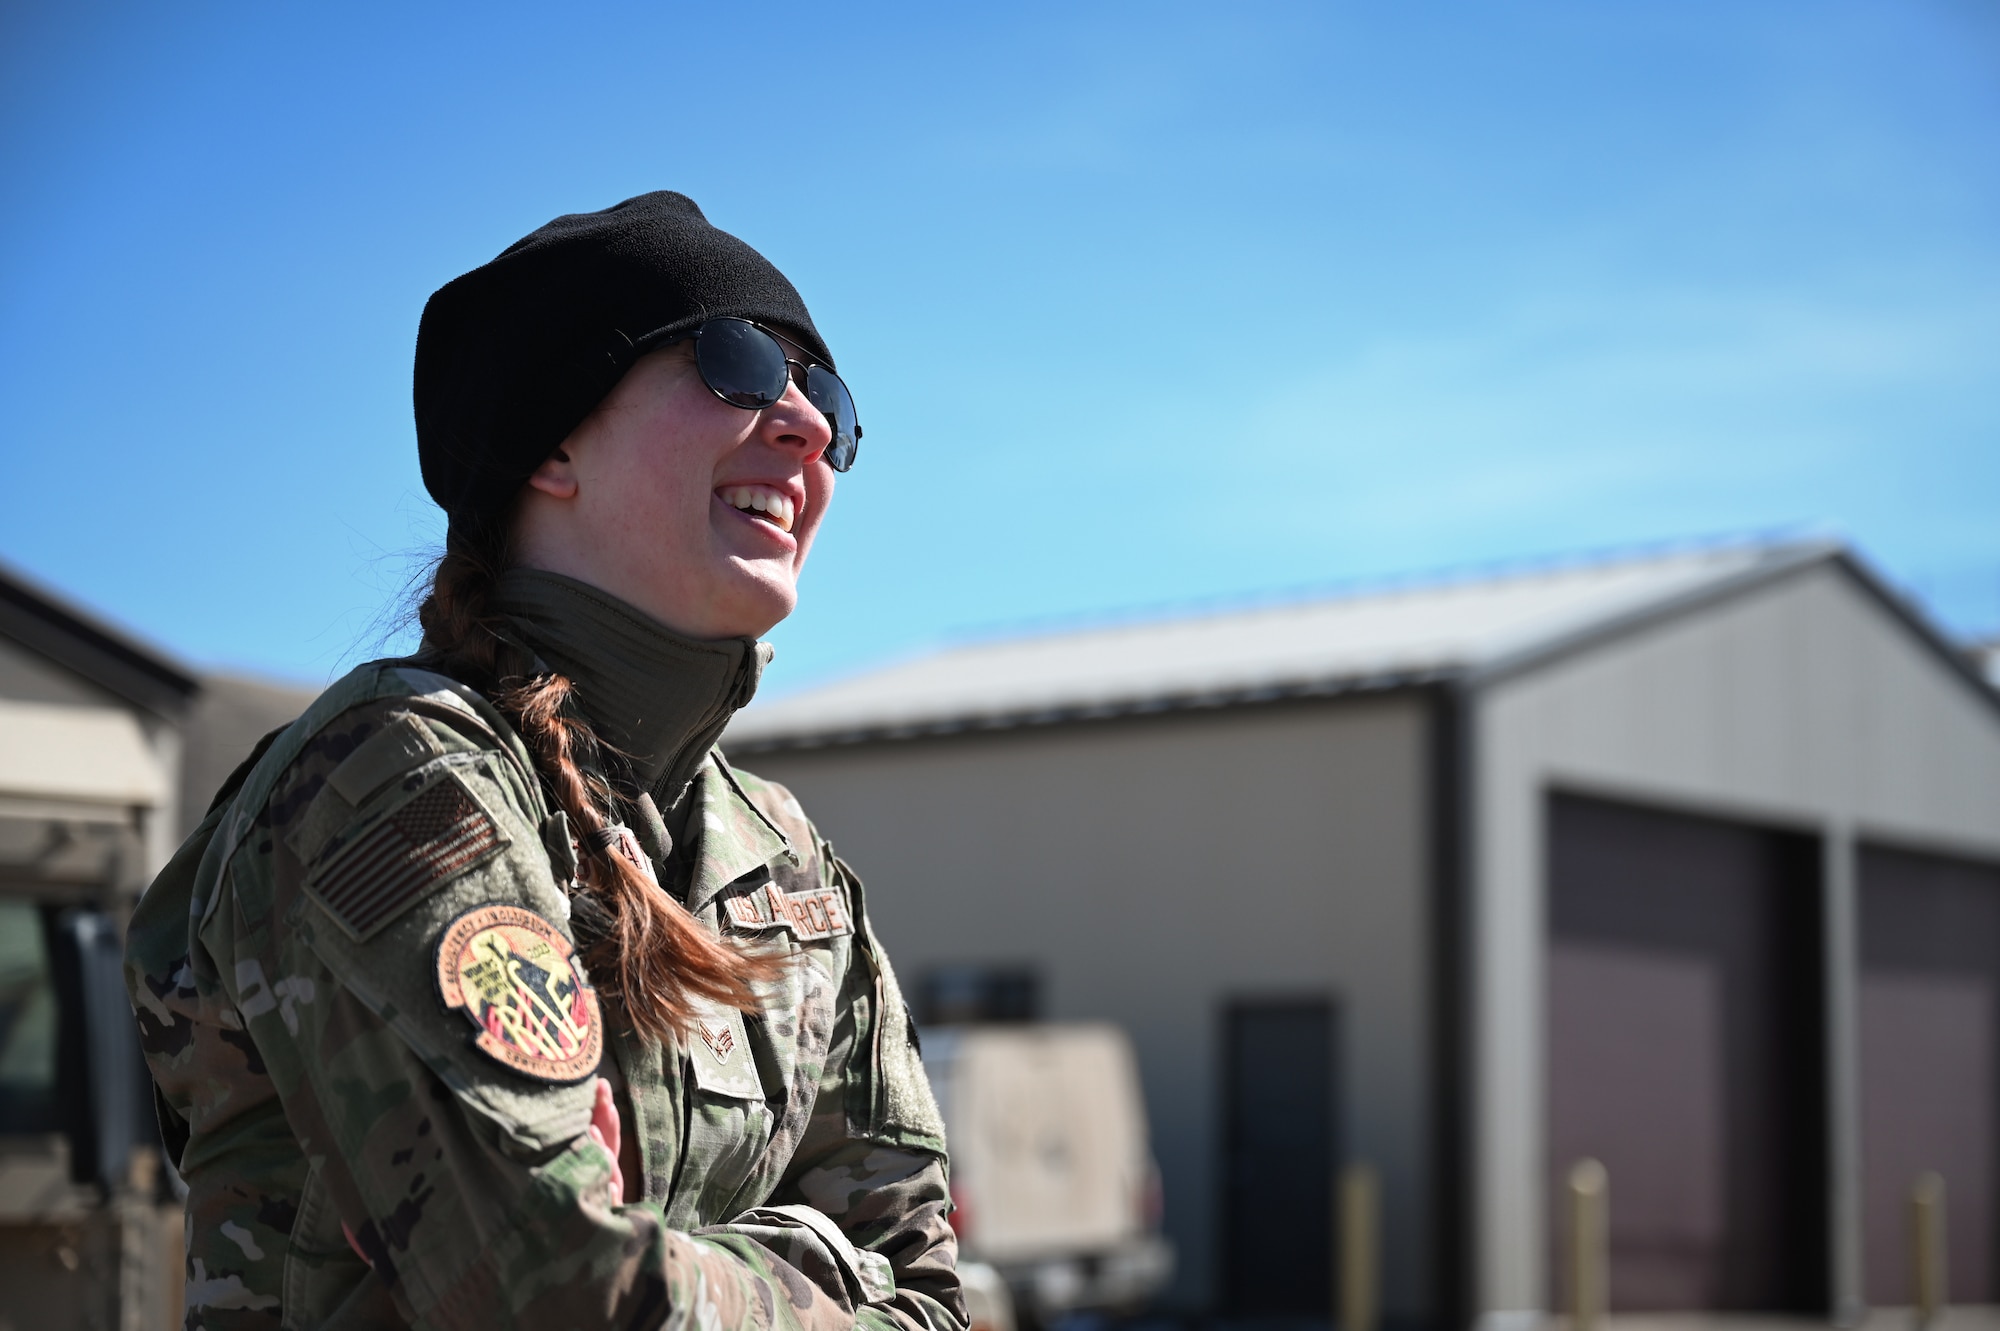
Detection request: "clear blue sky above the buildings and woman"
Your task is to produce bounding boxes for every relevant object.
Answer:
[0,0,2000,689]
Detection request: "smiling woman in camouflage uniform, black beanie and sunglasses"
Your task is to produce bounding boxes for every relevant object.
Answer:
[126,194,964,1331]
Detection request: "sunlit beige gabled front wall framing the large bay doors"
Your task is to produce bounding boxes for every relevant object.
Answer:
[1472,566,2000,1325]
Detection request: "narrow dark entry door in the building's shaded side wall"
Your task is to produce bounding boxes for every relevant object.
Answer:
[1222,997,1336,1317]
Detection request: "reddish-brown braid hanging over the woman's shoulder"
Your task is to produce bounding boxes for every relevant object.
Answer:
[416,528,778,1043]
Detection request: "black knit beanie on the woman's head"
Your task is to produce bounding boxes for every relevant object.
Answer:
[416,190,834,538]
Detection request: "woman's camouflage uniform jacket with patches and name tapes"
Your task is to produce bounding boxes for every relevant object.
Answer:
[126,662,966,1331]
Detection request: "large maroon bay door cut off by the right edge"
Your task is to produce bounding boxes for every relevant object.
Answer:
[1860,847,2000,1303]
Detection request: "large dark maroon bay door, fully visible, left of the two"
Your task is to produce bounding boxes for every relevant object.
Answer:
[1548,795,1828,1313]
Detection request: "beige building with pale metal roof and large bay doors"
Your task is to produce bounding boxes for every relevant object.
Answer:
[726,544,2000,1325]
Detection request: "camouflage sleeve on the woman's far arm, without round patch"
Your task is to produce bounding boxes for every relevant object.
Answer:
[752,843,968,1331]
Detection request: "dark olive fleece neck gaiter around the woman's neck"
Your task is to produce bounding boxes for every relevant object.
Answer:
[492,568,770,807]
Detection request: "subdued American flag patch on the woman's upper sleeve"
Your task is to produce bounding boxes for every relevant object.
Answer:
[306,775,508,939]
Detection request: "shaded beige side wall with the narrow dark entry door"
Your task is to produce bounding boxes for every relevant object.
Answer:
[744,693,1436,1315]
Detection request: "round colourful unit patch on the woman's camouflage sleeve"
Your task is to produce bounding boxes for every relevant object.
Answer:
[438,905,604,1081]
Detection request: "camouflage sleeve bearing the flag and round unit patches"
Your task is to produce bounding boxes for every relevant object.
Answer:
[213,699,876,1331]
